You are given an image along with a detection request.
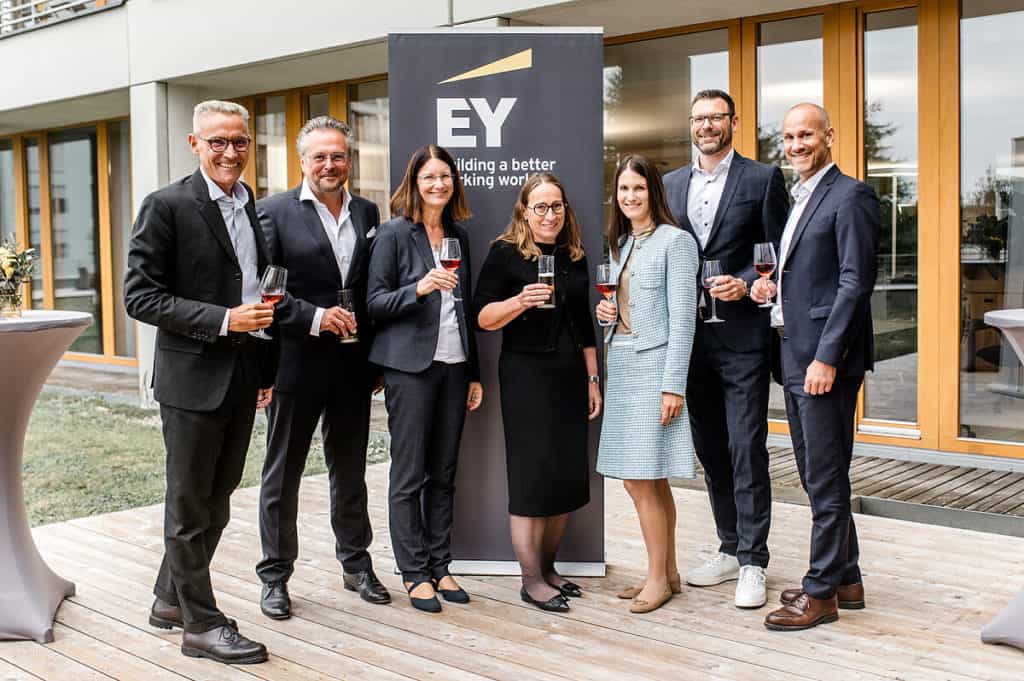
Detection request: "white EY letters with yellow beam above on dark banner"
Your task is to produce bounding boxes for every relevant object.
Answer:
[437,49,534,148]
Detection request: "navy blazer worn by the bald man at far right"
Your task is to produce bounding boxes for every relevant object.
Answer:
[773,166,882,388]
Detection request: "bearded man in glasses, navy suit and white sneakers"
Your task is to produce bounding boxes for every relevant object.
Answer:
[665,90,790,607]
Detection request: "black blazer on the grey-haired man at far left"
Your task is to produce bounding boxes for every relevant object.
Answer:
[125,170,280,412]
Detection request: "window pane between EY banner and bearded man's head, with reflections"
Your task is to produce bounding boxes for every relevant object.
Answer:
[604,30,729,228]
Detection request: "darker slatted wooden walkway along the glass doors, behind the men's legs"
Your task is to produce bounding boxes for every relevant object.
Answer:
[700,446,1024,517]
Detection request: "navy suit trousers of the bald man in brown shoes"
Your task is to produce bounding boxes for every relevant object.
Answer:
[785,376,863,598]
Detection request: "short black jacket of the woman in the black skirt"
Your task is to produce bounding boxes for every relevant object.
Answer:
[473,241,597,352]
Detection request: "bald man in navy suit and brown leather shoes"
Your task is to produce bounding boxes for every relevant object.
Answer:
[751,103,882,631]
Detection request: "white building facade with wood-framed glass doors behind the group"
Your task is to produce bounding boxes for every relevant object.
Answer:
[0,0,1024,458]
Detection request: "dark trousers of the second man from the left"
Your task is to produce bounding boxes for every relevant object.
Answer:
[256,357,373,582]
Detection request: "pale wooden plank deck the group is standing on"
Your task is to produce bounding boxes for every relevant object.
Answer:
[8,460,1024,681]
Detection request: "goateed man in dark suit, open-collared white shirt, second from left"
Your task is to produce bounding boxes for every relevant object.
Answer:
[256,116,390,620]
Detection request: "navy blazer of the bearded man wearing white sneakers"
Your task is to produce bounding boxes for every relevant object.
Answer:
[665,153,790,352]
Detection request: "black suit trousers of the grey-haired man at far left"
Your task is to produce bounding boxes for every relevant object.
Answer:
[153,343,262,633]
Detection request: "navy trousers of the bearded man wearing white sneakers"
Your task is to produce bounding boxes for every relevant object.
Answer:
[686,331,771,567]
